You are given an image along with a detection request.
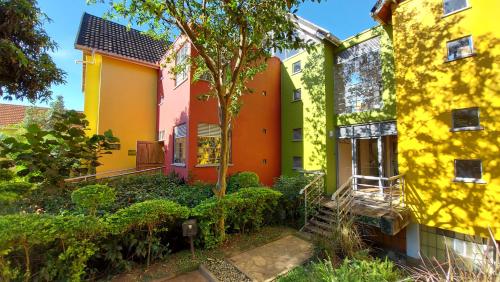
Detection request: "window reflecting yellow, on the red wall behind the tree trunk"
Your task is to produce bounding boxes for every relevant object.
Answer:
[198,123,231,165]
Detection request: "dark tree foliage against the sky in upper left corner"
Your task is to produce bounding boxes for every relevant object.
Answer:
[0,0,66,102]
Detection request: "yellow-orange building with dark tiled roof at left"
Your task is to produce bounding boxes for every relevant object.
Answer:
[75,14,166,173]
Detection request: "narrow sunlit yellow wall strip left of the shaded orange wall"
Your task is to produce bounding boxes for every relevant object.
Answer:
[83,53,102,136]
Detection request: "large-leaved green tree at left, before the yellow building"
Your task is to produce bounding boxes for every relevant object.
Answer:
[0,110,119,186]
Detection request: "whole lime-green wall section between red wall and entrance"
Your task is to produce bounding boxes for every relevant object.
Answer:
[281,44,336,192]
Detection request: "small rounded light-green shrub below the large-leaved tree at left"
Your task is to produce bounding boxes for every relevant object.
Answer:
[71,184,116,216]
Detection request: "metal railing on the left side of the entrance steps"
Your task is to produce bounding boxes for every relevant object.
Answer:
[299,172,325,229]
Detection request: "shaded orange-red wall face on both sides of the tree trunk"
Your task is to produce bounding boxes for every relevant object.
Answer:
[188,58,280,185]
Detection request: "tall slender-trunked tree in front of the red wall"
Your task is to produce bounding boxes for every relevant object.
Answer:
[94,0,314,236]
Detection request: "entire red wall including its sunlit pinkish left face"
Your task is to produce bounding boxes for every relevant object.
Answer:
[158,38,281,185]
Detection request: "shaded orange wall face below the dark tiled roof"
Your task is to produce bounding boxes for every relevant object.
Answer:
[97,56,158,172]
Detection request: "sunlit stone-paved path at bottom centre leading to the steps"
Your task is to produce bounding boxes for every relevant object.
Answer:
[229,235,314,282]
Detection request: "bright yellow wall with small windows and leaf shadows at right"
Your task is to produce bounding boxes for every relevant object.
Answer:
[393,0,500,240]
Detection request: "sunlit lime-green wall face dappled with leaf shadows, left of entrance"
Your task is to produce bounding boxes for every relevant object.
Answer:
[301,46,333,171]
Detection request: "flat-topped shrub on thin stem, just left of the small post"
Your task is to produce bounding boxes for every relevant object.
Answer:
[107,200,189,266]
